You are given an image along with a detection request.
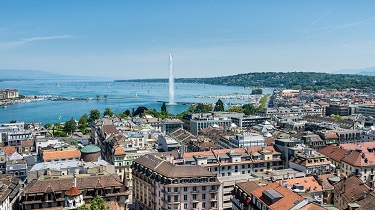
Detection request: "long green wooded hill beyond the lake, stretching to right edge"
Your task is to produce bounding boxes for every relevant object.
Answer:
[116,72,375,89]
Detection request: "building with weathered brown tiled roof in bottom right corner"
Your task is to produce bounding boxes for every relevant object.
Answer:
[334,176,370,209]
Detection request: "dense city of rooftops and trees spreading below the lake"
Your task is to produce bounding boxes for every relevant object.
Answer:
[0,87,375,210]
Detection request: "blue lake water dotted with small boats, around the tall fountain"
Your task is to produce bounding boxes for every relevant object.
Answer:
[0,80,272,124]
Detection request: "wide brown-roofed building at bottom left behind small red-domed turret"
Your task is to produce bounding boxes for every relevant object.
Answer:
[20,172,128,210]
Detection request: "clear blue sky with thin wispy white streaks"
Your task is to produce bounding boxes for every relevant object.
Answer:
[0,0,375,79]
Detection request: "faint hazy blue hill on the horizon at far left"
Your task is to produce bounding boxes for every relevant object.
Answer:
[0,69,103,81]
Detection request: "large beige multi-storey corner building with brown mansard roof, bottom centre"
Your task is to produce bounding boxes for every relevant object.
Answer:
[132,155,220,209]
